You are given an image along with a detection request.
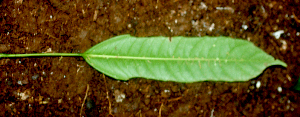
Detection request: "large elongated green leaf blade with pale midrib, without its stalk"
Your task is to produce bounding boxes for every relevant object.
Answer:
[83,35,287,82]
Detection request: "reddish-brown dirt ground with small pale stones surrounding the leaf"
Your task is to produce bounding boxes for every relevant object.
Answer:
[0,0,300,117]
